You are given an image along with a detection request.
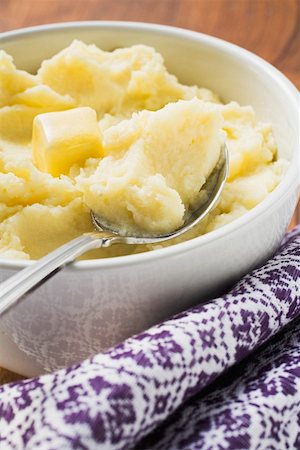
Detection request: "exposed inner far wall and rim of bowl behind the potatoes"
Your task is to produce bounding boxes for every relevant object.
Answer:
[0,22,299,165]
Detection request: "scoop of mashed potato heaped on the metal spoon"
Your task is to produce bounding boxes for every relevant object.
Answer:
[76,98,225,234]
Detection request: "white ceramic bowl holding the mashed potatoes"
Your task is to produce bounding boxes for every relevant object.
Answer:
[0,22,299,375]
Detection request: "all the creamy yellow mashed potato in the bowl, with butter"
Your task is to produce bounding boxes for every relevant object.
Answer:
[0,41,288,259]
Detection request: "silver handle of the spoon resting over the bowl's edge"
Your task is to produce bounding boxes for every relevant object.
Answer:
[0,232,120,316]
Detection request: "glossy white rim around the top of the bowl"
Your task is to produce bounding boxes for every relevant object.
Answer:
[0,21,300,271]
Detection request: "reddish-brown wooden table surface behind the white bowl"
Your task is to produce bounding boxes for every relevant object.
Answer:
[0,0,300,383]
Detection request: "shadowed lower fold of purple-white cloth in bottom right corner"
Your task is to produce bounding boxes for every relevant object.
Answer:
[135,319,300,450]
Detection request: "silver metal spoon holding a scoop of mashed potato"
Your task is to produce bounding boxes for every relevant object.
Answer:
[0,145,228,315]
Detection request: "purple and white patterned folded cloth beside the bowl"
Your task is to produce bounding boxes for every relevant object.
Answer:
[0,227,300,450]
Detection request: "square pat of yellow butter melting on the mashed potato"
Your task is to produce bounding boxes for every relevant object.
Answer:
[32,107,103,176]
